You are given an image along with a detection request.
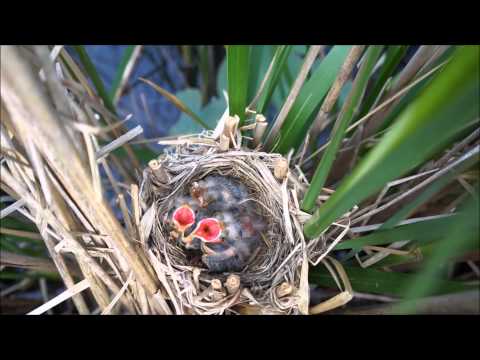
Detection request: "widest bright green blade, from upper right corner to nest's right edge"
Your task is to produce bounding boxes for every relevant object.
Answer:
[304,46,480,238]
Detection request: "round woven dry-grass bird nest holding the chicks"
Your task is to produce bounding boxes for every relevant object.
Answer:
[137,134,336,314]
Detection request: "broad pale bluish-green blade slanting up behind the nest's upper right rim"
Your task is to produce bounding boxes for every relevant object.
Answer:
[271,45,351,154]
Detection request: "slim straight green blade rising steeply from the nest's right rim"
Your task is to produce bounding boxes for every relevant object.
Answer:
[302,45,383,212]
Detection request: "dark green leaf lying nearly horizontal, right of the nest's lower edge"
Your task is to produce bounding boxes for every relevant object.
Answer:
[309,266,474,298]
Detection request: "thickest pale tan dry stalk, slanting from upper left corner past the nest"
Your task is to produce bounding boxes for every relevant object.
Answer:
[1,47,157,294]
